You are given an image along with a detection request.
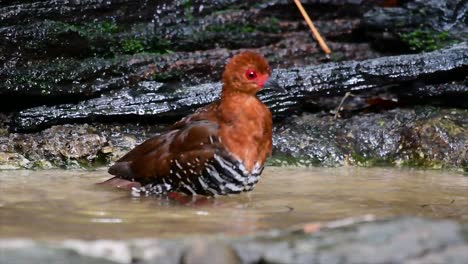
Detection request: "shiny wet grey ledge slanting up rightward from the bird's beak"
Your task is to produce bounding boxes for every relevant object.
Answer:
[275,43,468,94]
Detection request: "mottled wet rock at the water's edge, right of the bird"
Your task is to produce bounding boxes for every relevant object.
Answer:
[271,106,468,168]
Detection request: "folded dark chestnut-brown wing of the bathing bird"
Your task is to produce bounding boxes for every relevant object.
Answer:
[109,120,222,184]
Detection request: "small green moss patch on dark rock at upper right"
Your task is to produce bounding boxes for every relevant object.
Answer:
[400,28,455,51]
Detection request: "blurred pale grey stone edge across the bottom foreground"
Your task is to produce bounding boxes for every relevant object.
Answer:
[0,218,468,263]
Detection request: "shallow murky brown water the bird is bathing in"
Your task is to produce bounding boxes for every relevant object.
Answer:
[0,167,468,239]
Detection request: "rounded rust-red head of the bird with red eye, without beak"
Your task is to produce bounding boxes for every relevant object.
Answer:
[223,51,271,95]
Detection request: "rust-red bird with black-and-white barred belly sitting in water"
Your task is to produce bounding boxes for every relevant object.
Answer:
[104,51,279,196]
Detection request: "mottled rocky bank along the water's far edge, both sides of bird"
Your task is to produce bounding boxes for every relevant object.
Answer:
[0,106,468,169]
